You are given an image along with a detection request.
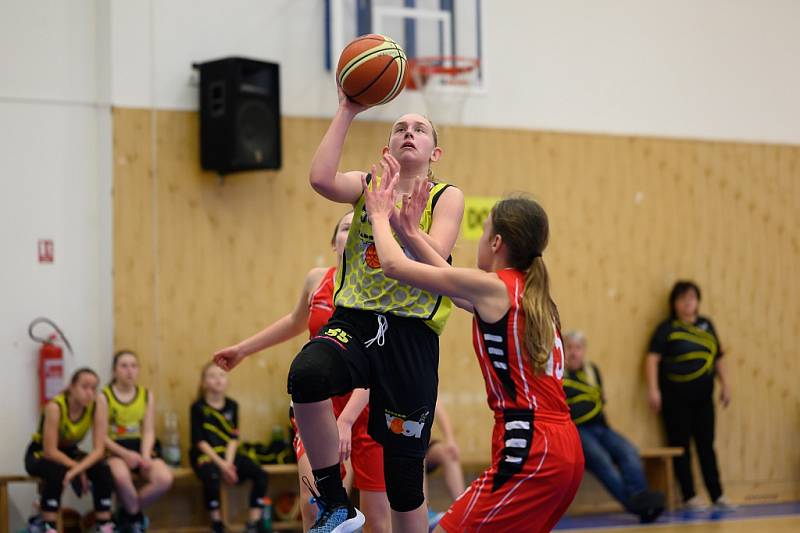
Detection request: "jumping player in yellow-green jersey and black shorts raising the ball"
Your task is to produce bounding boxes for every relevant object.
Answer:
[288,84,464,533]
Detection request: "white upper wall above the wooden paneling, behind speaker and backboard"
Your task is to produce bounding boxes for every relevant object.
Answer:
[112,0,800,143]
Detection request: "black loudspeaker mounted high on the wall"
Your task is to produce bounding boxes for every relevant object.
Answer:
[194,57,281,174]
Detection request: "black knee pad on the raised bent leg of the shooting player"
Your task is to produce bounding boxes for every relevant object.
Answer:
[286,342,352,403]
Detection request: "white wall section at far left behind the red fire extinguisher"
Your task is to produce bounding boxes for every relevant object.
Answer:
[0,0,113,530]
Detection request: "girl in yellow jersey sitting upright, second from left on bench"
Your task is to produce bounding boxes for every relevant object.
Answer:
[97,351,172,533]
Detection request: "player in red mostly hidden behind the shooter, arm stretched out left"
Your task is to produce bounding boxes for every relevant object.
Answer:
[214,211,390,533]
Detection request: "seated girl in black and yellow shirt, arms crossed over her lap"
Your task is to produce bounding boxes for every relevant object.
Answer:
[189,363,267,533]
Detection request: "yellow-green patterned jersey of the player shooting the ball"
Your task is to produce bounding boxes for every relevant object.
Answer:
[334,176,453,334]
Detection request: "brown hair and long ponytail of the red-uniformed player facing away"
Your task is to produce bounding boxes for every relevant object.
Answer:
[492,197,560,372]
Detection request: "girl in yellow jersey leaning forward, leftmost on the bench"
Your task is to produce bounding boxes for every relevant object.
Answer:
[25,368,114,533]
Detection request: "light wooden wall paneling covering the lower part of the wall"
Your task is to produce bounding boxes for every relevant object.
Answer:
[114,109,800,498]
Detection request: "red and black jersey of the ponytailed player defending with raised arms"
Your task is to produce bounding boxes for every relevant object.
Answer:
[472,268,569,415]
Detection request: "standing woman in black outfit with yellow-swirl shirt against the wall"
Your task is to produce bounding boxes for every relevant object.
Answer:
[646,281,733,511]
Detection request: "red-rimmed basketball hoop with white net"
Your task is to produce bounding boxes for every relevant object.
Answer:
[406,56,480,124]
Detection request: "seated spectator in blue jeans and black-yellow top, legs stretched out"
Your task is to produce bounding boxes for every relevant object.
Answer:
[564,331,665,523]
